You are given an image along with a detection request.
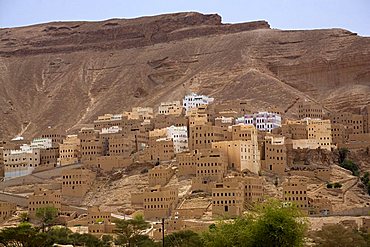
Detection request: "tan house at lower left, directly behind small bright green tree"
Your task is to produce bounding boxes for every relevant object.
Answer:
[28,187,62,217]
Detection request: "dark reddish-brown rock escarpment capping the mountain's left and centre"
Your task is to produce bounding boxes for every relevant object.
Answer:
[0,13,270,56]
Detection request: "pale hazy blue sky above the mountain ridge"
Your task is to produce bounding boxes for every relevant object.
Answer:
[0,0,370,36]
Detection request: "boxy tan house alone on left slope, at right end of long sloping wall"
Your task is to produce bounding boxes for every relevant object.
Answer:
[62,169,95,198]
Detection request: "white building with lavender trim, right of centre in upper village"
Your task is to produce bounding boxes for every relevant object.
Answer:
[236,112,281,132]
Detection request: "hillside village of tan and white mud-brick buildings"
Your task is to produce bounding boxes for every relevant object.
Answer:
[0,93,370,239]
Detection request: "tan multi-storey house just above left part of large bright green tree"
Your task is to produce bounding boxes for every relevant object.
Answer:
[212,181,244,218]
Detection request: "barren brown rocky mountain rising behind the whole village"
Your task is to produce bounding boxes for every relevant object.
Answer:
[0,13,370,139]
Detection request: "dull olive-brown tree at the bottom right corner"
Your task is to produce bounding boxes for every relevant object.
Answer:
[310,224,368,247]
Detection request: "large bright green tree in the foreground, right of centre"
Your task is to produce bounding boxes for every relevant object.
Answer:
[203,200,307,247]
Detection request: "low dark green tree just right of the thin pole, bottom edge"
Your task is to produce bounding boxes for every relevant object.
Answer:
[164,230,203,247]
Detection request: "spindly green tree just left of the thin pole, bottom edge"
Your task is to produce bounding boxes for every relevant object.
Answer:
[115,215,150,246]
